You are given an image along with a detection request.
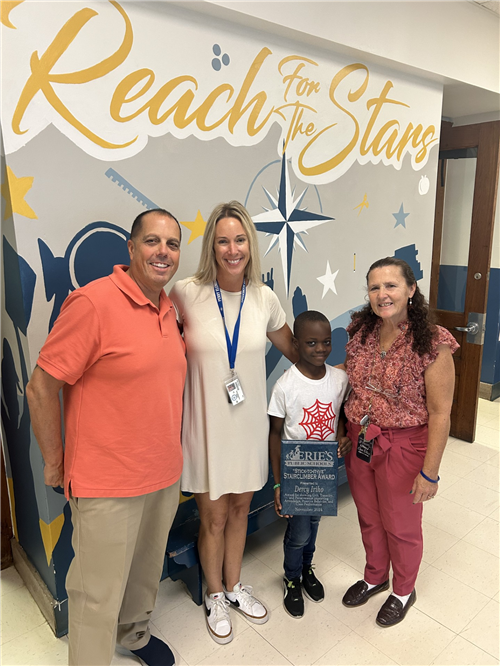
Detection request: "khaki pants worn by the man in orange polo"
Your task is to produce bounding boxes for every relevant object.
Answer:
[66,482,179,666]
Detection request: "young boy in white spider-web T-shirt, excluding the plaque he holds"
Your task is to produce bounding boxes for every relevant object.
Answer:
[267,310,351,618]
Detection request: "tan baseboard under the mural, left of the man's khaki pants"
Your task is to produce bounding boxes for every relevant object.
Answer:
[11,539,68,638]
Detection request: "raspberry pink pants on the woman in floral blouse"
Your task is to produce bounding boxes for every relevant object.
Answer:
[345,422,427,596]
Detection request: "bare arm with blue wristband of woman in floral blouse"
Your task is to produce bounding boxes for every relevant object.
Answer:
[412,345,455,504]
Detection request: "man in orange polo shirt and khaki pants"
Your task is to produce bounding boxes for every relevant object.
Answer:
[26,209,186,666]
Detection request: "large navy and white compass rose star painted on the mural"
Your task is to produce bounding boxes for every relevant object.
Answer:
[252,153,335,296]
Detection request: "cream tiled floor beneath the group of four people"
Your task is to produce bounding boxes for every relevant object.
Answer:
[0,400,500,666]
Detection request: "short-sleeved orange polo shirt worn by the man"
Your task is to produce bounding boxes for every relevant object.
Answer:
[37,266,186,497]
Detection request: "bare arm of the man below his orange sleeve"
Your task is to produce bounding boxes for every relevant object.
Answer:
[26,366,66,488]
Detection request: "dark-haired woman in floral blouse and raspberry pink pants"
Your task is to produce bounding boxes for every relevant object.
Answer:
[342,257,458,627]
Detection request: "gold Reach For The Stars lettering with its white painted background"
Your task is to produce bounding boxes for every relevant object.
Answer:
[2,0,438,176]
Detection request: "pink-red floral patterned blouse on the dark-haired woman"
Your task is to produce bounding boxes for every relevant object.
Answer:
[345,321,459,428]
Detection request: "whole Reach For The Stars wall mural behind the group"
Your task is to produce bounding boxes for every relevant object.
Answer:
[0,0,442,633]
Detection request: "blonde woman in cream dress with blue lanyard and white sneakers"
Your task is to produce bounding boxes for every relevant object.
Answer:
[170,201,297,644]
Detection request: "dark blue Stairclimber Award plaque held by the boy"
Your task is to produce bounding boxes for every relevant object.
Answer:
[280,439,339,516]
